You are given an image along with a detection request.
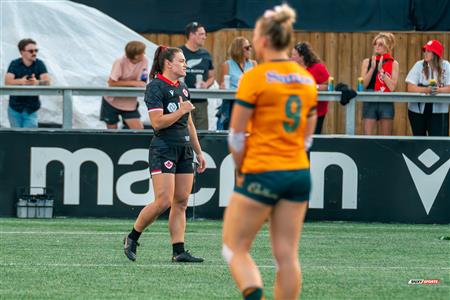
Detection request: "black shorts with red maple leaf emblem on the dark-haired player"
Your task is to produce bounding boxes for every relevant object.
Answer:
[148,144,194,176]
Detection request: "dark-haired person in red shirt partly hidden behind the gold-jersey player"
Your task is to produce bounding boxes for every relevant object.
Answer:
[291,42,330,134]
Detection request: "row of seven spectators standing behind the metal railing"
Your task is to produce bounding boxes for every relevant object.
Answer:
[4,22,450,136]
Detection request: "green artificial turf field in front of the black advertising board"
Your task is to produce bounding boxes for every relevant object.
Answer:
[0,218,450,299]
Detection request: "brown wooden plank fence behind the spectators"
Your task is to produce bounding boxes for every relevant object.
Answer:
[143,29,450,135]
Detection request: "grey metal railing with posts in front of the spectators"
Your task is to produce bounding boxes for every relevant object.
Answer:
[0,85,450,135]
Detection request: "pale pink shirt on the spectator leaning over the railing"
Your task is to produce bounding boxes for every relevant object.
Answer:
[104,56,149,111]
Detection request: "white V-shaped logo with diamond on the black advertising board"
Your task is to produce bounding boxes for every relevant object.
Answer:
[402,149,450,215]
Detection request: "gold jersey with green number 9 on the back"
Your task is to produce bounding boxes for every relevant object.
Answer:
[236,61,317,173]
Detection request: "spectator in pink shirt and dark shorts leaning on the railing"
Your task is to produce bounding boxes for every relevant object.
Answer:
[100,41,148,129]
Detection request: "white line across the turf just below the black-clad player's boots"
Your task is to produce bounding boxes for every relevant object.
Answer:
[0,262,450,271]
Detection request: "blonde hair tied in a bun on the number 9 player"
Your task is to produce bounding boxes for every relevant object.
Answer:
[257,3,296,50]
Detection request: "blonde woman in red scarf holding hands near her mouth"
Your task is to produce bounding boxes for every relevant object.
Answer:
[361,32,399,135]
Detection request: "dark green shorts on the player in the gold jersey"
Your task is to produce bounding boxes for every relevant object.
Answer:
[234,169,311,205]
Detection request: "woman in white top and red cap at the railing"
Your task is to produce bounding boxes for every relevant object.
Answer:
[405,40,450,136]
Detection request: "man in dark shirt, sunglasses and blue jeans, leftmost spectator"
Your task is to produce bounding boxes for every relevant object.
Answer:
[5,39,50,128]
